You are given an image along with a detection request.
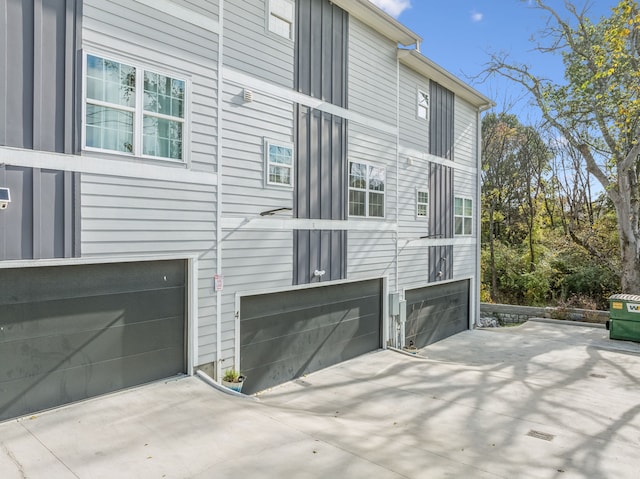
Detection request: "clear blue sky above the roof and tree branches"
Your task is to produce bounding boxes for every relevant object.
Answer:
[371,0,618,121]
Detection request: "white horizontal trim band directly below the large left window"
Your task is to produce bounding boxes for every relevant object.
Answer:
[0,146,218,186]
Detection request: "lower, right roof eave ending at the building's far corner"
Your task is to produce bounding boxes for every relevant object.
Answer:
[398,48,495,111]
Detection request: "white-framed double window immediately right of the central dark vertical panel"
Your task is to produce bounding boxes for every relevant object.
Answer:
[349,161,386,218]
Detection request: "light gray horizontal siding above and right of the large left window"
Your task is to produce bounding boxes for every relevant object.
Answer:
[83,0,218,172]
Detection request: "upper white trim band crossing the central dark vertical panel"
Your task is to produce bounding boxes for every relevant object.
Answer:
[222,67,398,135]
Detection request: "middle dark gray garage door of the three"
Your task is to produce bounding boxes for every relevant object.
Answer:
[240,280,382,394]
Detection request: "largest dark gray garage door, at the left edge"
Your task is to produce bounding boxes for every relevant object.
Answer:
[0,261,185,420]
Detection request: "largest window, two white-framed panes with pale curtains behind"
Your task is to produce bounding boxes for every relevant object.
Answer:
[84,54,186,161]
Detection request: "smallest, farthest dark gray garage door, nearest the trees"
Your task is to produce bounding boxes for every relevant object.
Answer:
[405,280,469,348]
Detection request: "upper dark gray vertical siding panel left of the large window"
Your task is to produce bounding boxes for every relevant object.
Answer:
[0,0,80,153]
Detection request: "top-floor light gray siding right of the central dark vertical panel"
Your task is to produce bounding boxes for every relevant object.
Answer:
[347,16,397,126]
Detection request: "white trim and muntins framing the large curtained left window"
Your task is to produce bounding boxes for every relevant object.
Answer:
[81,49,191,165]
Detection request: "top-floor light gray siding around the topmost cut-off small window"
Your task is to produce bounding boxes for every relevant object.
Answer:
[224,0,295,88]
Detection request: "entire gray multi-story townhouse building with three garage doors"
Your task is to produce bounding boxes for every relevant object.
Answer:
[0,0,492,420]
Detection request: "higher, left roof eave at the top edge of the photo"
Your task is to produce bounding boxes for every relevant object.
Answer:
[331,0,422,47]
